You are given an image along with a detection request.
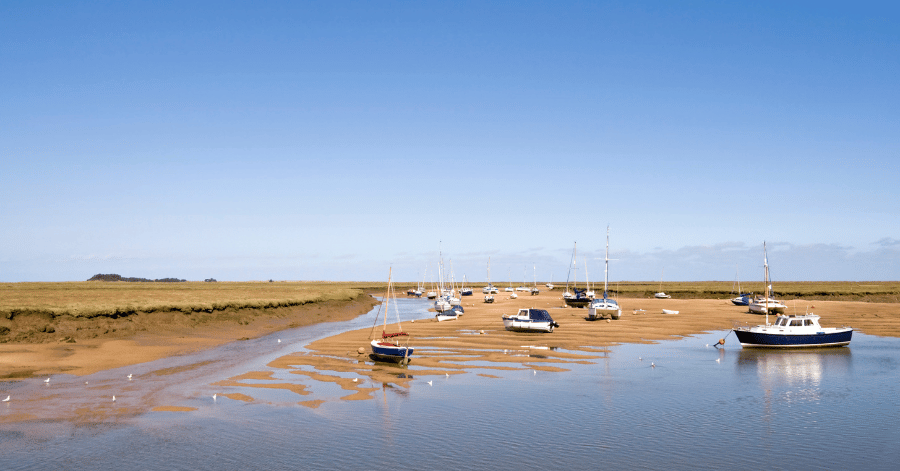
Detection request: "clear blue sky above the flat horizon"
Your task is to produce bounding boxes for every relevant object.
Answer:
[0,1,900,282]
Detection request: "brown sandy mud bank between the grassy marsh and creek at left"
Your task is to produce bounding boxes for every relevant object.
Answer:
[0,293,378,380]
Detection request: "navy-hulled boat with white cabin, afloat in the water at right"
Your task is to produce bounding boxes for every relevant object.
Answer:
[733,242,853,348]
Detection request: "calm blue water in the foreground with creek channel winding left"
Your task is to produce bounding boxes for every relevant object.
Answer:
[0,300,900,470]
